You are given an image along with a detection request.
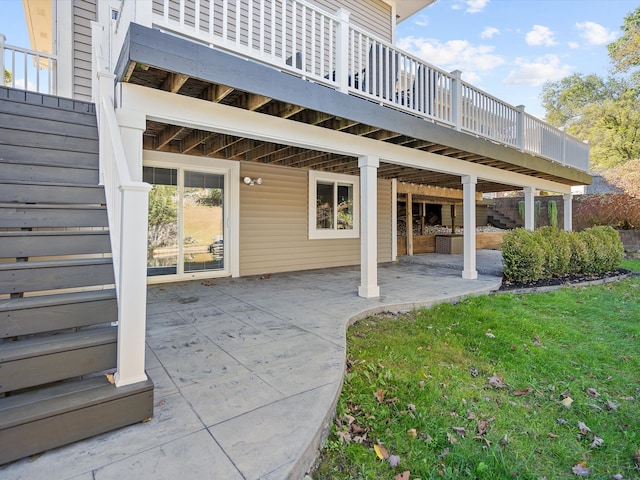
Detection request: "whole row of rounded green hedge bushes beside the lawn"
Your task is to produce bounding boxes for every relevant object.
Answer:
[502,227,624,283]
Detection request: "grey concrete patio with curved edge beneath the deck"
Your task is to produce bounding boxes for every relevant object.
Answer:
[0,252,501,480]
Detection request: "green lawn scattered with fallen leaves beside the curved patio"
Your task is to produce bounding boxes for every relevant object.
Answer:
[312,261,640,480]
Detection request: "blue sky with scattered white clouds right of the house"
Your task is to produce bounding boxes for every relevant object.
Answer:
[396,0,640,118]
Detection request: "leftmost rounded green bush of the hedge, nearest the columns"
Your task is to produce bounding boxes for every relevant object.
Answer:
[502,228,545,283]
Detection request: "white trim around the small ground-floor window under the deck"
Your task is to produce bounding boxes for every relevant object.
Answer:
[308,170,360,240]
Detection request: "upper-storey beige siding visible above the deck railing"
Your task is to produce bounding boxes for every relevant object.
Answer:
[311,0,394,43]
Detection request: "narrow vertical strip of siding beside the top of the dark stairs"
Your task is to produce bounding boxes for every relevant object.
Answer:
[73,0,96,101]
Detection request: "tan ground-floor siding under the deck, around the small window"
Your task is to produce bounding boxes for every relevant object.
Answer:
[239,162,392,275]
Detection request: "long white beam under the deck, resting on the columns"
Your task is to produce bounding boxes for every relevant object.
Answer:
[118,83,571,193]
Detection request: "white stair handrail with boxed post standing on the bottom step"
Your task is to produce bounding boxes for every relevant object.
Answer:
[92,23,151,387]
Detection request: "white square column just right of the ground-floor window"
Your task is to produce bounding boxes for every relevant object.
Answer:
[358,156,380,298]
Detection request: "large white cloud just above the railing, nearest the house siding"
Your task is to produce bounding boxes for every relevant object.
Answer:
[398,37,505,82]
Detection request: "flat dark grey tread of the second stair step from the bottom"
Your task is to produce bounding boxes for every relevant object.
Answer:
[0,327,118,363]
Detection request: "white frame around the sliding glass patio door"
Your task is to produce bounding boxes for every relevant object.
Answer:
[142,150,240,278]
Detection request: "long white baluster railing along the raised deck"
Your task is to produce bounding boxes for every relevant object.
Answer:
[113,0,589,171]
